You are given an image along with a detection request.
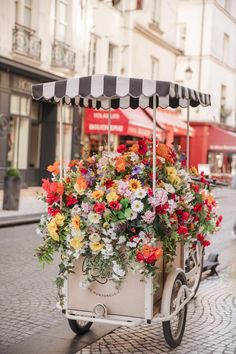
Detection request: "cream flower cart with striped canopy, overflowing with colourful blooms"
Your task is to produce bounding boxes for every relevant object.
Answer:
[32,75,220,347]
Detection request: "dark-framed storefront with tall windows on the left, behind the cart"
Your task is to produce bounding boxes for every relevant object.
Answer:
[0,58,80,187]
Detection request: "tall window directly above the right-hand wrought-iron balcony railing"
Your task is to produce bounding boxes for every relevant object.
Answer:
[55,0,68,43]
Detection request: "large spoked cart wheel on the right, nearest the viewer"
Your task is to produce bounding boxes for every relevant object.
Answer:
[162,273,187,348]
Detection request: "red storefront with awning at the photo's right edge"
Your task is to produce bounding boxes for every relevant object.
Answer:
[190,122,236,176]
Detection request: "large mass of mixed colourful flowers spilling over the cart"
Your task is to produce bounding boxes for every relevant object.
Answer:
[36,140,221,300]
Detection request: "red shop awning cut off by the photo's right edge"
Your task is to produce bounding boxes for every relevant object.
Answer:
[208,125,236,152]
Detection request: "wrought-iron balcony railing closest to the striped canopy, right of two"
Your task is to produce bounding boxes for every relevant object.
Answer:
[52,42,75,71]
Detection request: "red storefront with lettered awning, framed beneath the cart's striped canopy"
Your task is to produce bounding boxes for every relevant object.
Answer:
[83,108,165,154]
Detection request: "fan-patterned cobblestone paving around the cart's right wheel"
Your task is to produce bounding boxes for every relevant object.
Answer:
[78,266,236,354]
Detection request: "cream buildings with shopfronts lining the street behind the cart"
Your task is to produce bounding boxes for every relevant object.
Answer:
[0,0,236,185]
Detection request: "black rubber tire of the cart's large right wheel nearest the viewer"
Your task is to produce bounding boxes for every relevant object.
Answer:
[162,273,187,348]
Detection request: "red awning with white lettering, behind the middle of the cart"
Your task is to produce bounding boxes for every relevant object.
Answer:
[84,108,163,140]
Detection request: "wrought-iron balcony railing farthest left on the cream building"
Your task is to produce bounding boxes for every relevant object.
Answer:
[12,25,41,60]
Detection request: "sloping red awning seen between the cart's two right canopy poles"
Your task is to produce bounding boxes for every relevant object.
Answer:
[146,108,194,136]
